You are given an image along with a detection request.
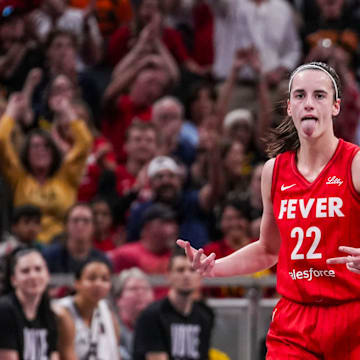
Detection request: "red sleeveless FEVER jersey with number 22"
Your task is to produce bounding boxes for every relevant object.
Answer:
[272,139,360,304]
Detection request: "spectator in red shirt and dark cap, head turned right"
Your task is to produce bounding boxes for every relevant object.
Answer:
[109,204,179,274]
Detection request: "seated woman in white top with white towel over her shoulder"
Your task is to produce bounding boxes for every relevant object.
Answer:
[58,260,120,360]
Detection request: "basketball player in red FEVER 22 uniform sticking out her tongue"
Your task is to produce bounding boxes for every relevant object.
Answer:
[178,63,360,360]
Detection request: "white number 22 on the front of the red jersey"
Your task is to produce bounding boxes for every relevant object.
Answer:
[290,226,322,260]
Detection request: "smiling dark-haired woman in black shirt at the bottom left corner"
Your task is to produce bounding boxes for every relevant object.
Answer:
[0,249,58,360]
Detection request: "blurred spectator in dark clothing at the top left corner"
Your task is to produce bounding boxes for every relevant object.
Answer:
[0,0,43,96]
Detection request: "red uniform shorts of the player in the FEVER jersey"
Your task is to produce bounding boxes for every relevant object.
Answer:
[266,298,360,360]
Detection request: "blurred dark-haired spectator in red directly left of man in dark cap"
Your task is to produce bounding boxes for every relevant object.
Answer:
[91,197,125,252]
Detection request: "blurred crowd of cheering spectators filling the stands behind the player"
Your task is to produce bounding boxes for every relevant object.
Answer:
[0,0,360,359]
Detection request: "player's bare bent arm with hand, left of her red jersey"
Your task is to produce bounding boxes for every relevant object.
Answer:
[177,159,280,277]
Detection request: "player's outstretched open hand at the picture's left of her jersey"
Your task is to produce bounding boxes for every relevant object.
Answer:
[176,239,215,277]
